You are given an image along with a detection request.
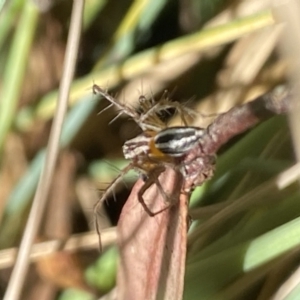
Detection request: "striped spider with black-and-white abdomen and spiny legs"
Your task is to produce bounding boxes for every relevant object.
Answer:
[93,84,214,216]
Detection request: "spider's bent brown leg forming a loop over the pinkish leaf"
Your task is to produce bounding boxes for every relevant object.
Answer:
[137,165,180,217]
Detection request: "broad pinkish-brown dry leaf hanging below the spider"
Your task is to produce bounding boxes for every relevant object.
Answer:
[117,169,188,300]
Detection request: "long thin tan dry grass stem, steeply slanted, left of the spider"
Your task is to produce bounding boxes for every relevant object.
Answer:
[4,0,84,300]
